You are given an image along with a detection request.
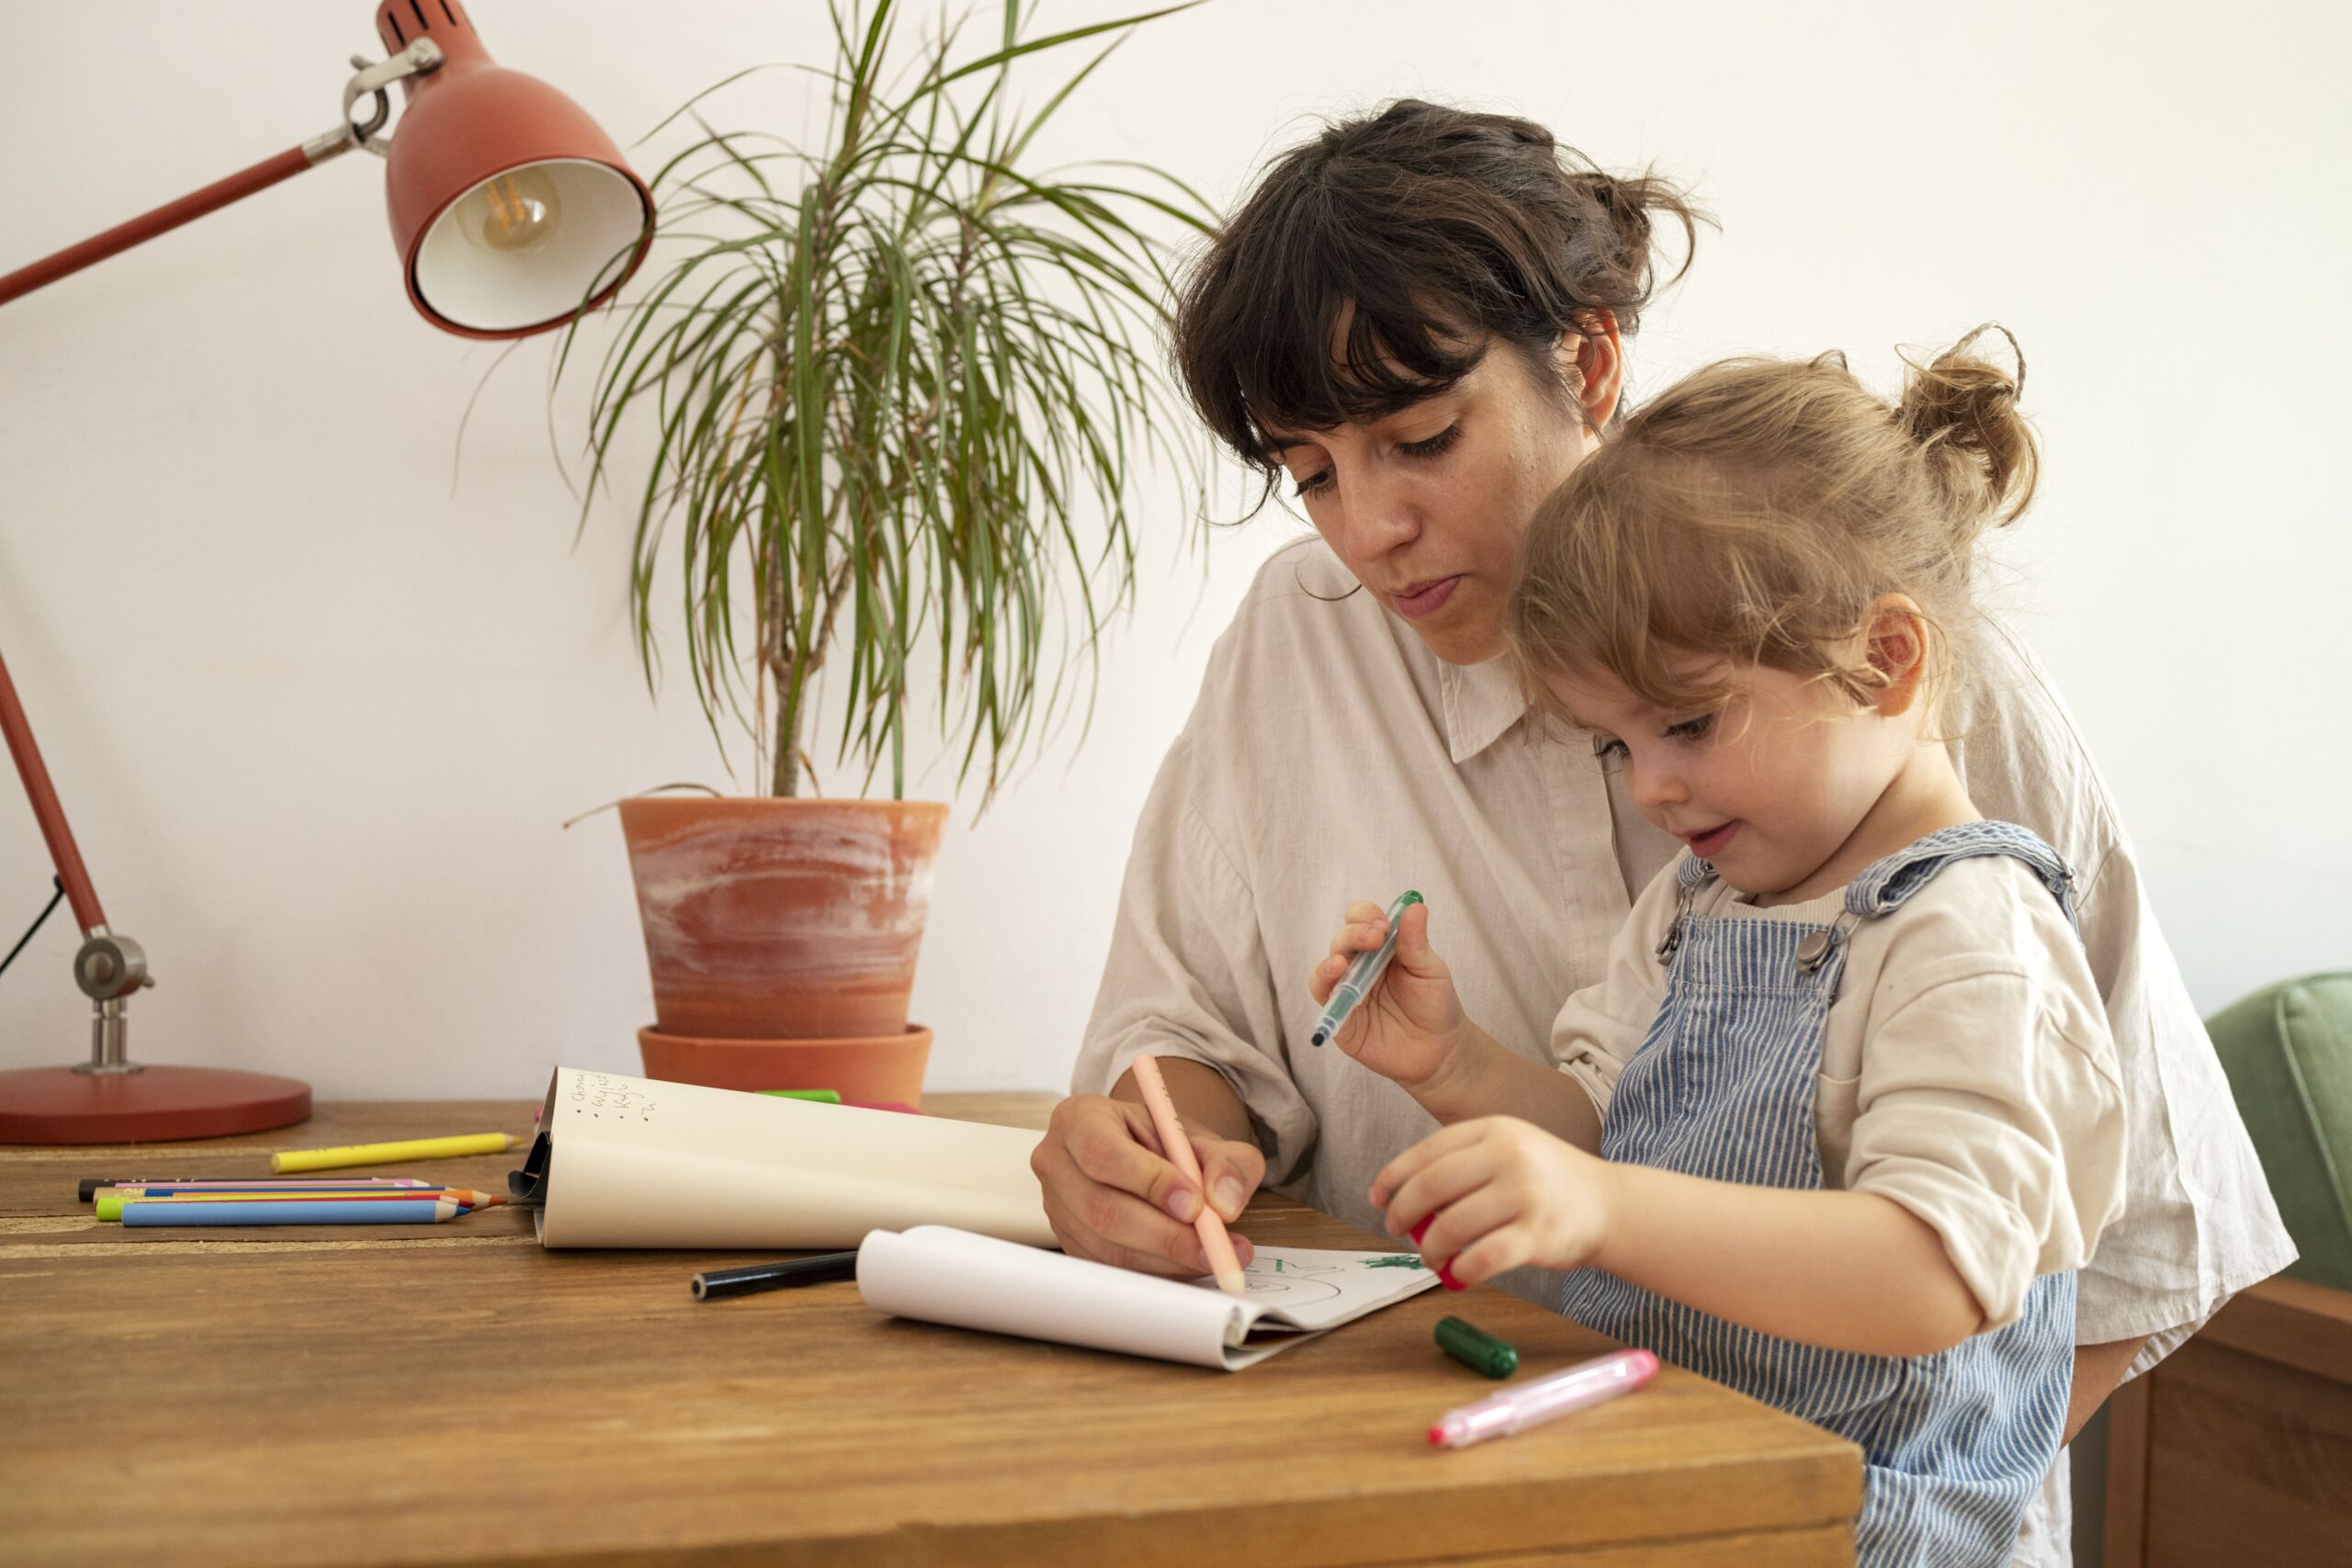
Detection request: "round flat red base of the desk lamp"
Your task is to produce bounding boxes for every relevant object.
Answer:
[0,1067,311,1143]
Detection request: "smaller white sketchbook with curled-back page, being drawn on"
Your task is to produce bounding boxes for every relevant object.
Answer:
[858,1224,1437,1373]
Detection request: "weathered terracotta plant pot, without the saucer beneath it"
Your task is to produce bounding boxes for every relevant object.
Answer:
[621,795,948,1042]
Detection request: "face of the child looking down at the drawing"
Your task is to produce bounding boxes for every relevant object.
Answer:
[1547,653,1917,898]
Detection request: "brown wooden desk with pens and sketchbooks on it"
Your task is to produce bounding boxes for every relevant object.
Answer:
[0,1096,1860,1568]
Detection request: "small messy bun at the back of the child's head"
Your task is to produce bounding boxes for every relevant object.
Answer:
[1895,322,2040,543]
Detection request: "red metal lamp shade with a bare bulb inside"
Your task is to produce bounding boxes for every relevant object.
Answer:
[377,0,654,339]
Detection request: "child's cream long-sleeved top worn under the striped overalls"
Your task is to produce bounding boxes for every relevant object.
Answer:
[1553,856,2124,1328]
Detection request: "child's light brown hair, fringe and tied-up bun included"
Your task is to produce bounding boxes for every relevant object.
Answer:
[1505,324,2040,717]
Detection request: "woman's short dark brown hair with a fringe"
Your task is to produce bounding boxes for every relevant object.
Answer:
[1173,98,1705,470]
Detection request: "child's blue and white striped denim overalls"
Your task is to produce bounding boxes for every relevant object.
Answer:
[1559,823,2075,1568]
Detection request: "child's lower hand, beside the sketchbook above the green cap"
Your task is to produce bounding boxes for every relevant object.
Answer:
[1371,1117,1616,1286]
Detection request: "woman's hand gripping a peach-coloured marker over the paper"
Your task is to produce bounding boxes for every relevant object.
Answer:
[1030,1096,1265,1279]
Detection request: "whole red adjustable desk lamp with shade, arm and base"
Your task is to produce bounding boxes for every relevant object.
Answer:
[0,0,654,1143]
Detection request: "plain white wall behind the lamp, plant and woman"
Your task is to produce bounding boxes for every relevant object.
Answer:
[0,0,2352,1096]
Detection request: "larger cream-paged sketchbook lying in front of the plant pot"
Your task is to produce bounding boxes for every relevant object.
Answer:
[529,1067,1054,1251]
